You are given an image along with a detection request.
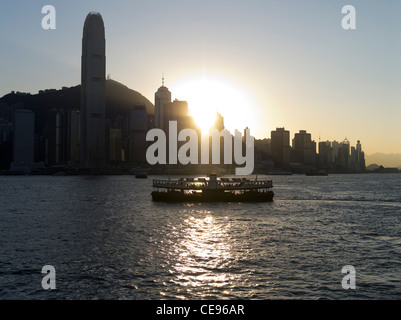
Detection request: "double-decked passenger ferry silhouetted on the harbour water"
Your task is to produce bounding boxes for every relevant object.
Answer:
[152,174,274,202]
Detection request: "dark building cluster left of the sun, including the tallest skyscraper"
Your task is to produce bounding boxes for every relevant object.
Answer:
[0,12,208,173]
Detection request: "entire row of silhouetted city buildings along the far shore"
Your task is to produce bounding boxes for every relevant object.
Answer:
[0,12,365,173]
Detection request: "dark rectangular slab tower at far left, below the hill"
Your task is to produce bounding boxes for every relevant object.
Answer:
[13,110,35,166]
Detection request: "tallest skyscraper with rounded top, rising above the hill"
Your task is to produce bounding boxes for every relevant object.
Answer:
[80,12,106,168]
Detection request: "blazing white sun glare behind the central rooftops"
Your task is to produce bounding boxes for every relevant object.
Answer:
[172,76,253,134]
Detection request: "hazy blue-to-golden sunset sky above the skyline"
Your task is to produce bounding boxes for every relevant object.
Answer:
[0,0,401,155]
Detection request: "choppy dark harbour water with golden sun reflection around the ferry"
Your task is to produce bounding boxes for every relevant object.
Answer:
[0,174,401,299]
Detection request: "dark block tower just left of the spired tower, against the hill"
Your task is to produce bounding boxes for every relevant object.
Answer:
[129,105,148,164]
